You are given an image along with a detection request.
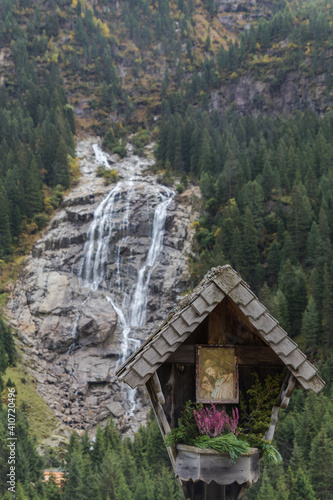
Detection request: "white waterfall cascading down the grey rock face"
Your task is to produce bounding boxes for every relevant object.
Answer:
[78,144,174,414]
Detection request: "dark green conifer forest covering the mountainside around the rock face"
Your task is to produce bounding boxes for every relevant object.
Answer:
[0,0,333,500]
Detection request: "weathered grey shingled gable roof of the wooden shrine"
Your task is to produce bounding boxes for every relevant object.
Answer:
[117,265,325,393]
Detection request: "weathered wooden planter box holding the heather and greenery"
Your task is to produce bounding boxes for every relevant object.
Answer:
[176,444,260,485]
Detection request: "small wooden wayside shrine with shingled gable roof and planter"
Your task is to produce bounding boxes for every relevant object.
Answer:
[117,266,324,500]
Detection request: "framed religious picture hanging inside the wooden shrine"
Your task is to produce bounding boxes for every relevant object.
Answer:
[196,345,239,403]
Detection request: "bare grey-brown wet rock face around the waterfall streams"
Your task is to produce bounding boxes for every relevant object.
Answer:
[7,138,198,433]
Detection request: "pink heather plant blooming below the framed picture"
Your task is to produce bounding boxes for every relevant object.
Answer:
[193,403,239,437]
